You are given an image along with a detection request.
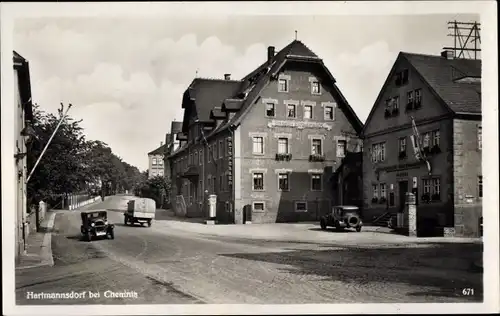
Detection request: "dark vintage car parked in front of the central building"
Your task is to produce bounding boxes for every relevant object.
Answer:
[320,205,363,232]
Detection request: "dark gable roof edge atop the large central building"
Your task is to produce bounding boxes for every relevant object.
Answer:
[207,40,363,137]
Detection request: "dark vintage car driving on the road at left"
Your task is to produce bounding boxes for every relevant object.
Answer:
[80,211,115,241]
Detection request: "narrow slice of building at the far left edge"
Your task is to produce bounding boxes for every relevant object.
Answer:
[13,51,33,262]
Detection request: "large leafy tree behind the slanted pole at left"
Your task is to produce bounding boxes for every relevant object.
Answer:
[27,104,144,206]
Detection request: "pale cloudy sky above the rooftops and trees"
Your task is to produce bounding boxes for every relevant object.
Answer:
[13,14,479,170]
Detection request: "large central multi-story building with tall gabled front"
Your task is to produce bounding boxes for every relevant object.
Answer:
[169,40,362,223]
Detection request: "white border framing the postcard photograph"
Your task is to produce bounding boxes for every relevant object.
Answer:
[0,1,500,315]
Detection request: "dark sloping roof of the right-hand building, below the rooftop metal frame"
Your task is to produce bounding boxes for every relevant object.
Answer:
[401,52,481,114]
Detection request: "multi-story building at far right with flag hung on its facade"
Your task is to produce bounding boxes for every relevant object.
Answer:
[362,51,483,236]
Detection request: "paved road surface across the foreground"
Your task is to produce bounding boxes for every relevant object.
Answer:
[16,196,482,305]
